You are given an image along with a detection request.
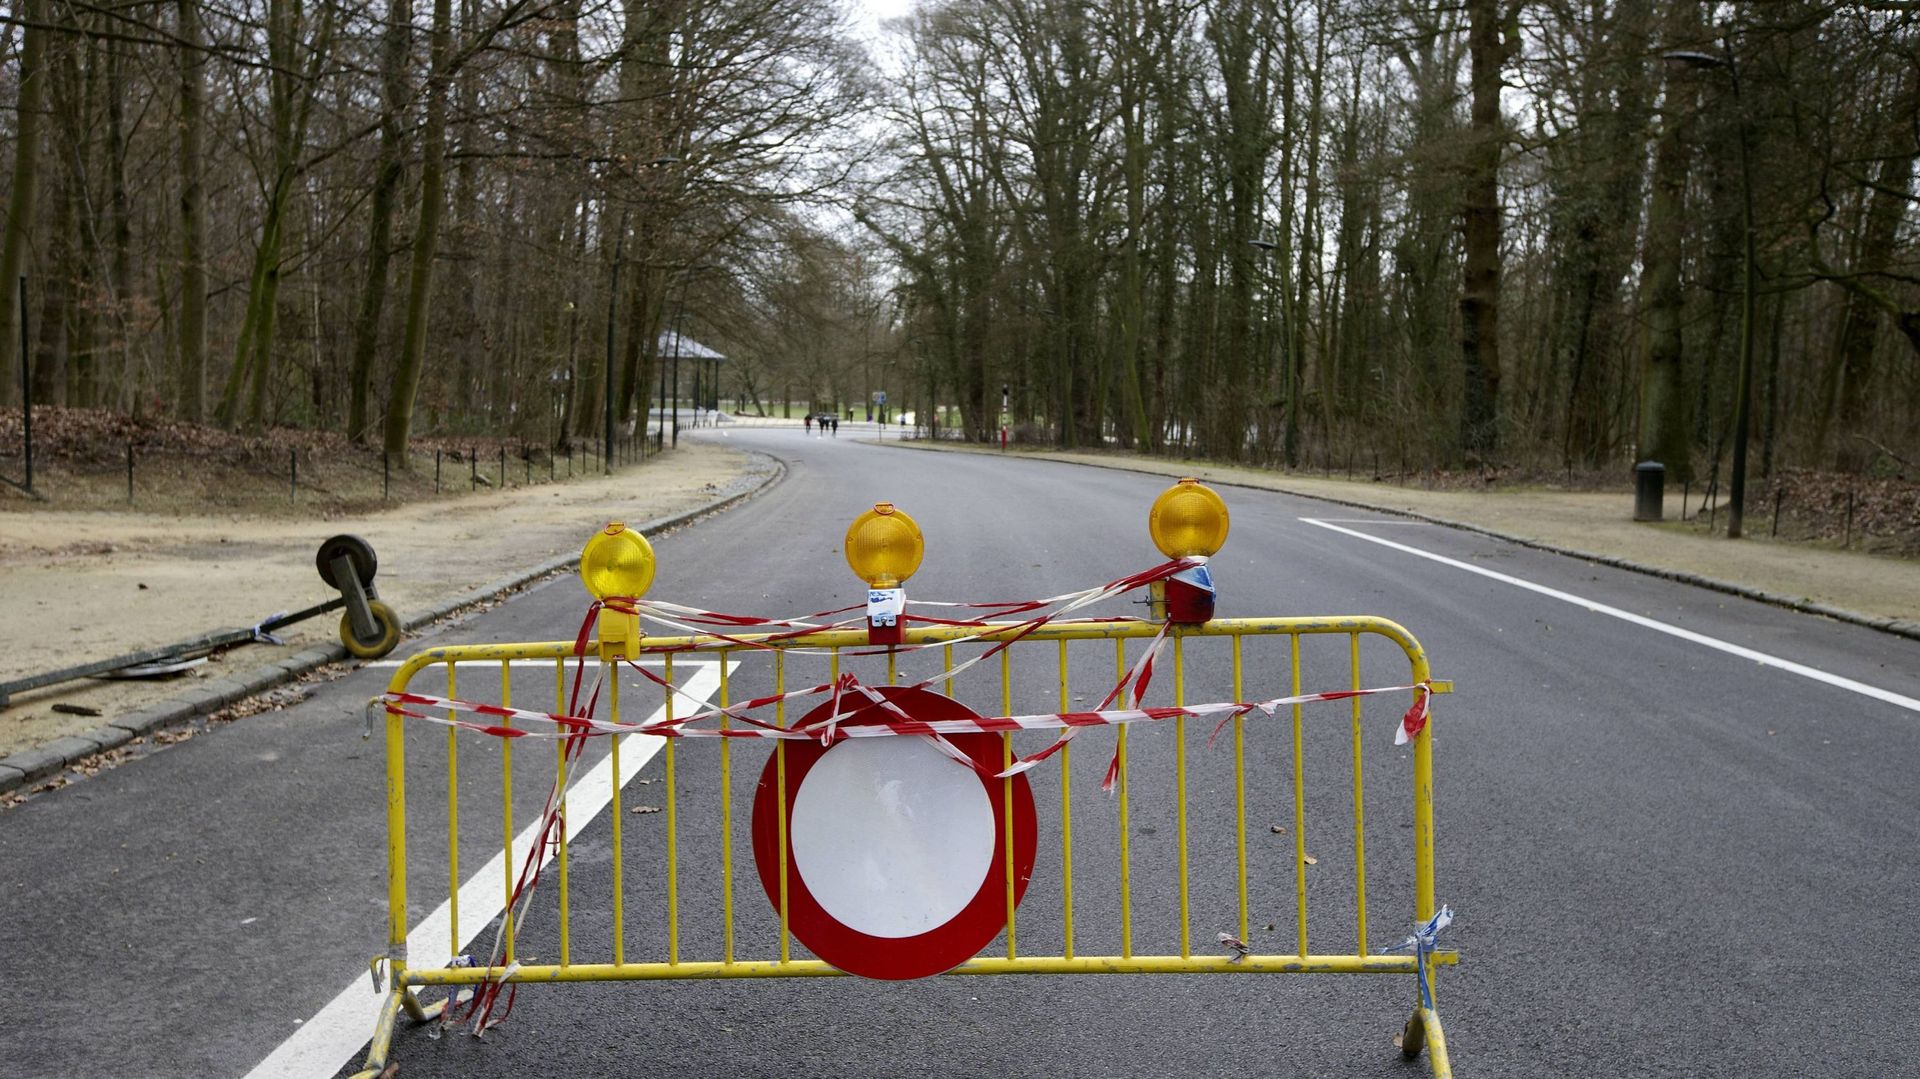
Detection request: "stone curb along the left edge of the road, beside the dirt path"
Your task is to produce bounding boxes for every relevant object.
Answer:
[0,453,787,795]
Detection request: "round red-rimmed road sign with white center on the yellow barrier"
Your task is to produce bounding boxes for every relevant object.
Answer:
[753,685,1035,979]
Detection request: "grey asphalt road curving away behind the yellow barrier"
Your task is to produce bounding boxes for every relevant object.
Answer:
[0,428,1920,1077]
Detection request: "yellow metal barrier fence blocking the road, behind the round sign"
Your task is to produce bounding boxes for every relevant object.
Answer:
[367,616,1455,1075]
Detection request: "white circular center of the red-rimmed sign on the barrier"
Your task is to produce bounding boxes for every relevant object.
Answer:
[791,737,996,937]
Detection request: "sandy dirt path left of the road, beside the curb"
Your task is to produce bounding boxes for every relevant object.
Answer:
[0,442,753,756]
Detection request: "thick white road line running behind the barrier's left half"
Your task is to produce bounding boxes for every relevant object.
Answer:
[246,660,720,1079]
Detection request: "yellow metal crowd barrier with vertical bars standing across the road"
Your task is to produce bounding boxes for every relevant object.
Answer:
[363,616,1457,1075]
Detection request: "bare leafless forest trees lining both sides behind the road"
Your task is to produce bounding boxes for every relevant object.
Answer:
[0,0,1920,482]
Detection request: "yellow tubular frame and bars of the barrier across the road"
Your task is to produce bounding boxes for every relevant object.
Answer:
[357,616,1457,1079]
